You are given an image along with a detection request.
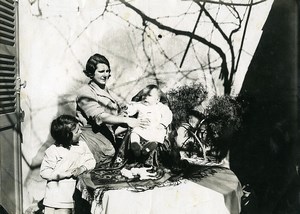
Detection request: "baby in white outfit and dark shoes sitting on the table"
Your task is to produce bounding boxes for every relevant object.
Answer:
[127,85,173,166]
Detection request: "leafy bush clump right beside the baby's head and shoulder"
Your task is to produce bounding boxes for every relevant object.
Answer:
[166,83,207,129]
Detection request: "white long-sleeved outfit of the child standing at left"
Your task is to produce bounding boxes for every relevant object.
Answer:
[40,141,96,208]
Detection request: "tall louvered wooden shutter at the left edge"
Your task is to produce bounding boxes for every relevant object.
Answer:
[0,0,23,214]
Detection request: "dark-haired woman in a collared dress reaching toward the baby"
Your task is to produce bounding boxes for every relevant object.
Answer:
[76,54,147,167]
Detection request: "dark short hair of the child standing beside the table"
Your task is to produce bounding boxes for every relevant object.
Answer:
[50,114,78,148]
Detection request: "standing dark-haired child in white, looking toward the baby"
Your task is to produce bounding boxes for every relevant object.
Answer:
[40,115,96,214]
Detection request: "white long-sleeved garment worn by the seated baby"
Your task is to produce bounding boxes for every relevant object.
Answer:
[127,102,173,143]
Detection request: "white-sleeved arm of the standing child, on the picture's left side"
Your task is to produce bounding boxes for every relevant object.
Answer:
[40,147,72,181]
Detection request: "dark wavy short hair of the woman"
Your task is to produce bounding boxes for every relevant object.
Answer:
[83,53,110,78]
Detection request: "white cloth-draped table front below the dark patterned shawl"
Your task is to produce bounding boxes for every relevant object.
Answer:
[81,167,242,214]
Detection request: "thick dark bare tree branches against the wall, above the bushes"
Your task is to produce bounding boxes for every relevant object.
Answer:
[119,0,266,94]
